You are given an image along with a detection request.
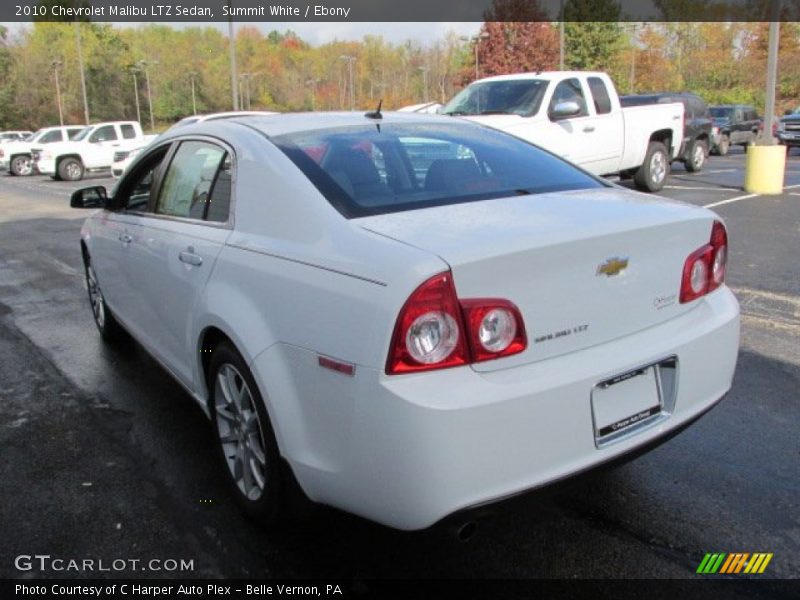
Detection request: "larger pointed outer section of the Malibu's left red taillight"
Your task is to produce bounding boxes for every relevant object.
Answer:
[386,272,469,374]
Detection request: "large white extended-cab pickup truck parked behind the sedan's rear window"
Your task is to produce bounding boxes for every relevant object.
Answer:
[441,71,683,192]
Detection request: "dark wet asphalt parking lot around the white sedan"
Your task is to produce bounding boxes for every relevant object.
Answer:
[0,149,800,584]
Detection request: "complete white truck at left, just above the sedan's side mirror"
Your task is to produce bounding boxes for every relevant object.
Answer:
[32,121,155,181]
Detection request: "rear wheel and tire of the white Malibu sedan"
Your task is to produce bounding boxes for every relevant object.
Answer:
[208,342,286,527]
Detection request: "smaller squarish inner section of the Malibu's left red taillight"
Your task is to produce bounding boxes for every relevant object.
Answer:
[461,298,527,362]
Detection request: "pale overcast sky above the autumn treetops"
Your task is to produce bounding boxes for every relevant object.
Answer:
[2,21,481,46]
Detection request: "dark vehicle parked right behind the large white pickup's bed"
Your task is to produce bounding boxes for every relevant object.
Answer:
[620,92,713,171]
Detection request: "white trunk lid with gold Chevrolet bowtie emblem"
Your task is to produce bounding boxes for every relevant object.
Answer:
[354,188,714,371]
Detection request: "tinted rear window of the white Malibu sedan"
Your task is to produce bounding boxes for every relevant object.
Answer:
[271,123,604,218]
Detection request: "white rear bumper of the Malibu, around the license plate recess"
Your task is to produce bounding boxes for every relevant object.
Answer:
[260,288,739,529]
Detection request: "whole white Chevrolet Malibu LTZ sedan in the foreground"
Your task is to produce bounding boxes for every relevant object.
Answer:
[72,112,739,529]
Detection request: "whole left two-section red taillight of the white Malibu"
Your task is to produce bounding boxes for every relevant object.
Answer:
[386,271,527,375]
